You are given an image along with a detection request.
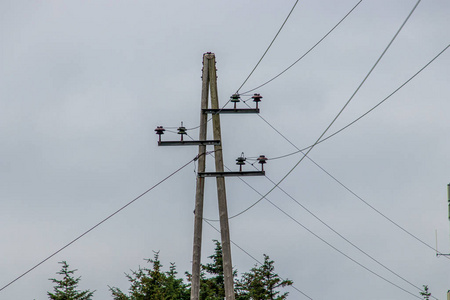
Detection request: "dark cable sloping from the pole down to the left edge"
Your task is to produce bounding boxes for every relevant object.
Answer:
[0,155,200,292]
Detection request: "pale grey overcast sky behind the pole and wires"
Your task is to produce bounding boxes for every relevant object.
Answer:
[0,0,450,300]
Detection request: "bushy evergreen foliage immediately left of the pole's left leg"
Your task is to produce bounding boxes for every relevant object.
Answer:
[110,252,190,300]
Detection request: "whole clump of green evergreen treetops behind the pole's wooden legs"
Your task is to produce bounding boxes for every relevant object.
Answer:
[110,240,292,300]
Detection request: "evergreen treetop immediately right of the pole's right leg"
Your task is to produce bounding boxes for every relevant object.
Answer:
[236,254,293,300]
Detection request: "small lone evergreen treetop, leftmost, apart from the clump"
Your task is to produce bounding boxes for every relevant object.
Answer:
[47,261,95,300]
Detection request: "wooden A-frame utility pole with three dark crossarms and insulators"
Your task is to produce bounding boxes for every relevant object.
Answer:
[155,52,267,300]
